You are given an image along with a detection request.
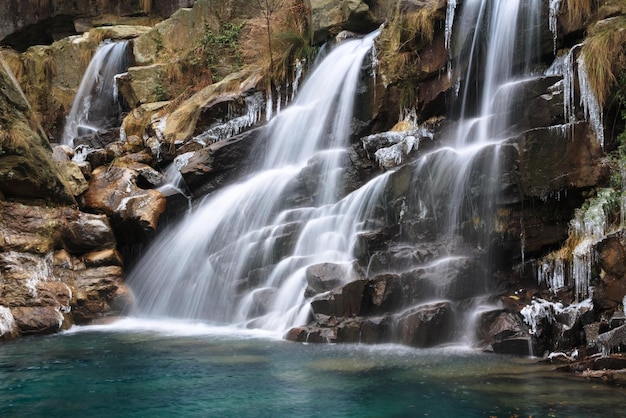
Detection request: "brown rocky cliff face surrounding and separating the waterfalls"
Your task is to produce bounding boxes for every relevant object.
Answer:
[0,0,626,370]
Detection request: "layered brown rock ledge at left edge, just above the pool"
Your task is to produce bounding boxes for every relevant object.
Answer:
[0,200,133,339]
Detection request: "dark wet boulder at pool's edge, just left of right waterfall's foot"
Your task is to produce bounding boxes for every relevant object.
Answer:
[396,302,454,347]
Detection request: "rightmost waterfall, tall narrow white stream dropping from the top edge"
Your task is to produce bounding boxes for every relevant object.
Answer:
[386,0,542,338]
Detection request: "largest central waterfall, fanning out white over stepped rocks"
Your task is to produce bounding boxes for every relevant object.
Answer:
[128,32,380,332]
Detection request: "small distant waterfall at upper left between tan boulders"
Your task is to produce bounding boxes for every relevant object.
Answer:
[61,41,128,146]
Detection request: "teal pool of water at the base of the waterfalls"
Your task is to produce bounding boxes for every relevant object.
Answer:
[0,320,626,417]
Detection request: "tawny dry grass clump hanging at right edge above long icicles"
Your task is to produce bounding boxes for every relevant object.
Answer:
[582,16,626,105]
